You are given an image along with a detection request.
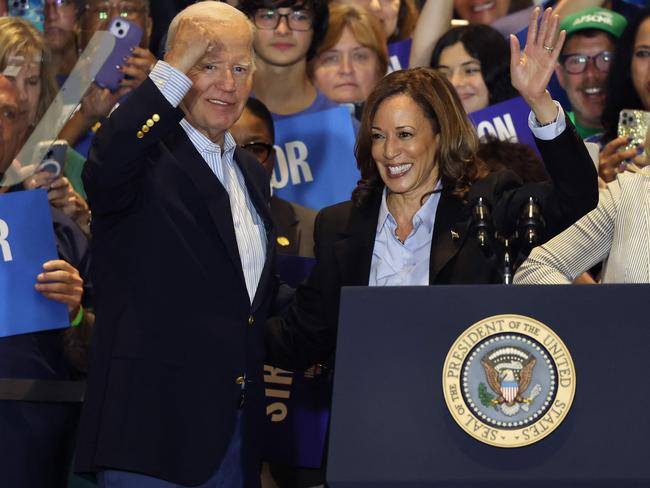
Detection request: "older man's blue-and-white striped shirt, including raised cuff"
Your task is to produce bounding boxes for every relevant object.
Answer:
[149,61,267,302]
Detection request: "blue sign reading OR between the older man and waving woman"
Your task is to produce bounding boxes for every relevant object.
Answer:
[271,107,359,210]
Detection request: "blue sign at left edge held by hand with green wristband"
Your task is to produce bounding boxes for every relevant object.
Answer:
[0,190,70,337]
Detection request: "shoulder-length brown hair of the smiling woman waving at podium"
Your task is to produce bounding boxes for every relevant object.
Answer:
[352,68,488,207]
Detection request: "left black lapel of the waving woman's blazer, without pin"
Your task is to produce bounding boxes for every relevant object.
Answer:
[334,194,381,286]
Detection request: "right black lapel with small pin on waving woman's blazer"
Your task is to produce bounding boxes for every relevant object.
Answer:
[429,192,469,284]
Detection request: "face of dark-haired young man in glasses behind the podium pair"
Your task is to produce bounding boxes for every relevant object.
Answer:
[255,7,314,66]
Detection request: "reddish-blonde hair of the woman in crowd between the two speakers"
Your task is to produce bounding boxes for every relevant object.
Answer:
[307,3,388,78]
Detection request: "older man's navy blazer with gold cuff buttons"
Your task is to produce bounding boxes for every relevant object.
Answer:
[76,80,275,486]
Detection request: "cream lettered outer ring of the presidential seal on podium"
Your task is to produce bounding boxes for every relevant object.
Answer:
[442,313,576,449]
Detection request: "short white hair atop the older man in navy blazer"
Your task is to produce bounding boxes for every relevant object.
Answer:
[165,1,255,51]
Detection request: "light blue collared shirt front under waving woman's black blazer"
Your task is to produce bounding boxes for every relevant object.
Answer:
[368,183,441,286]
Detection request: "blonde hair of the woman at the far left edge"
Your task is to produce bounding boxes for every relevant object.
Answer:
[0,17,58,125]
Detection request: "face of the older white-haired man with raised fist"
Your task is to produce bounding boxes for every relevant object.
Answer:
[181,19,253,144]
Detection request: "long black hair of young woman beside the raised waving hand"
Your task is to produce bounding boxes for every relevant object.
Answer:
[430,24,519,105]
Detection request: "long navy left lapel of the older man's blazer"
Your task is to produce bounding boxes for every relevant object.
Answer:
[167,125,246,286]
